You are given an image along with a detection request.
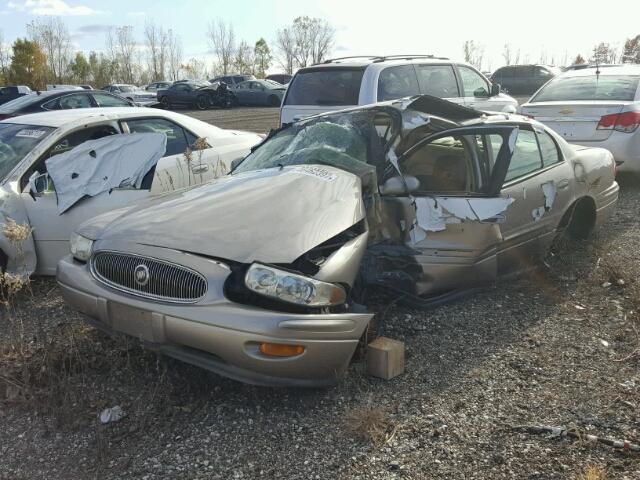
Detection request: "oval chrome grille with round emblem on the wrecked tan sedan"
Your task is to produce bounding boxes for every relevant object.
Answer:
[91,251,207,303]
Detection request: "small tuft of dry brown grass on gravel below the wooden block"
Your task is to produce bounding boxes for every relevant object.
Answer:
[345,404,397,447]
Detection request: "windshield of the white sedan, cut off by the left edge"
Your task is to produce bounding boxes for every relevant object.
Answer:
[0,123,54,179]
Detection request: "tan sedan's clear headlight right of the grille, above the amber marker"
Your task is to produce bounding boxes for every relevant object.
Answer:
[244,263,347,307]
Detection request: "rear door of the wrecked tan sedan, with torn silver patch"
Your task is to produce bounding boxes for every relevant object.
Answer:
[498,126,574,274]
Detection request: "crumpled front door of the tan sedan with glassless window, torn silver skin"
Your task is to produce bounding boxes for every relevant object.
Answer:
[381,126,517,295]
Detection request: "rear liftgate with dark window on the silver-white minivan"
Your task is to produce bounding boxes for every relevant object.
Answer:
[280,65,365,124]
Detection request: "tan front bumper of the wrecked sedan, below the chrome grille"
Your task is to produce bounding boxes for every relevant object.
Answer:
[57,247,373,387]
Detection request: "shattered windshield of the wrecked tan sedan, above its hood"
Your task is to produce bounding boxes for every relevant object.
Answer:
[234,109,398,179]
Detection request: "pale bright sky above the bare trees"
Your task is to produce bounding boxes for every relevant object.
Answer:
[0,0,640,71]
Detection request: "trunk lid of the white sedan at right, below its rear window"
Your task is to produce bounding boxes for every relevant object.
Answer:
[522,101,629,142]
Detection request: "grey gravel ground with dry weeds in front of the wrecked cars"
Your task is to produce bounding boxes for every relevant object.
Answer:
[0,167,640,480]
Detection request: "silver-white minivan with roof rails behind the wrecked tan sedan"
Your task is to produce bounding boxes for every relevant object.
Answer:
[280,55,518,124]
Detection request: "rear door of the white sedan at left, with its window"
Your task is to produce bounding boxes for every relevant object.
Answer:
[121,117,226,194]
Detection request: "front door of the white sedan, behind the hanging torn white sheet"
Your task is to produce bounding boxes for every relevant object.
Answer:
[19,124,149,275]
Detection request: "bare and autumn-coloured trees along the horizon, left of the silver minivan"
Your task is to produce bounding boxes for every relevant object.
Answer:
[0,16,335,89]
